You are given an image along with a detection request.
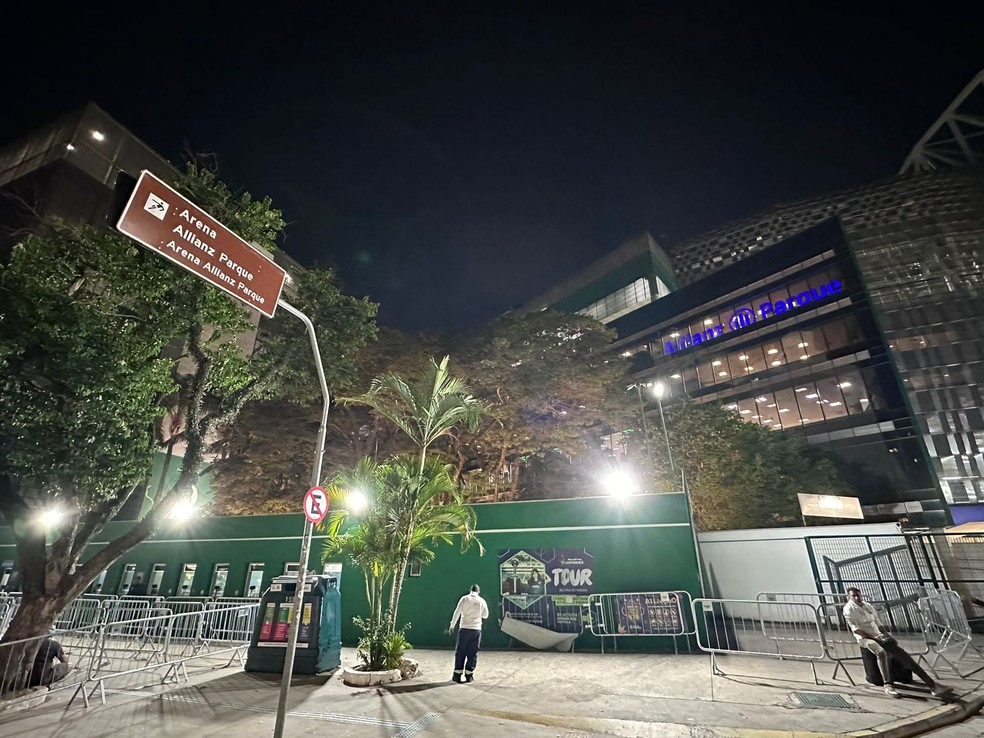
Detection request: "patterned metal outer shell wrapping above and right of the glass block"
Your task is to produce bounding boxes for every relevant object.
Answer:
[669,166,984,516]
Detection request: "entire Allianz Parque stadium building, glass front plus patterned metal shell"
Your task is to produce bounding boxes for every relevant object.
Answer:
[524,166,984,525]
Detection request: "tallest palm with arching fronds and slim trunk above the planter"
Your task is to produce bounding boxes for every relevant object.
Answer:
[342,356,487,628]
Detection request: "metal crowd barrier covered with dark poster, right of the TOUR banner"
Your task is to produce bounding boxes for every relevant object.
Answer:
[585,591,695,653]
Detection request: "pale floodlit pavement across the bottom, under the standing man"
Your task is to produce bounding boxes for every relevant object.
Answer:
[0,649,984,738]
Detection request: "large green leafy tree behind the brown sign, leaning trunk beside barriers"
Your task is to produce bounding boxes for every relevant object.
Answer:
[0,162,375,680]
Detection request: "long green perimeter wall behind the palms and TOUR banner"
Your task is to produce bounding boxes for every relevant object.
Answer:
[0,494,699,650]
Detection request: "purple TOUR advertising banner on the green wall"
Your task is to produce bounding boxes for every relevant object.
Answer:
[499,548,594,633]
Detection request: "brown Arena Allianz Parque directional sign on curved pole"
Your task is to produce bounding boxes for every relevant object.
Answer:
[116,171,286,318]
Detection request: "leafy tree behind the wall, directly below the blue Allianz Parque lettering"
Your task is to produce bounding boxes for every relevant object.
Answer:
[636,402,847,530]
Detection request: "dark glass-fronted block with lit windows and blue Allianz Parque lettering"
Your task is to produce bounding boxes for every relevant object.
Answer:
[612,221,946,524]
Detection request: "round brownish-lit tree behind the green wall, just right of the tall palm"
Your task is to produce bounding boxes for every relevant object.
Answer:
[451,310,634,497]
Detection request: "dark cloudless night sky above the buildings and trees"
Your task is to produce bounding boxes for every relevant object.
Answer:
[7,1,984,331]
